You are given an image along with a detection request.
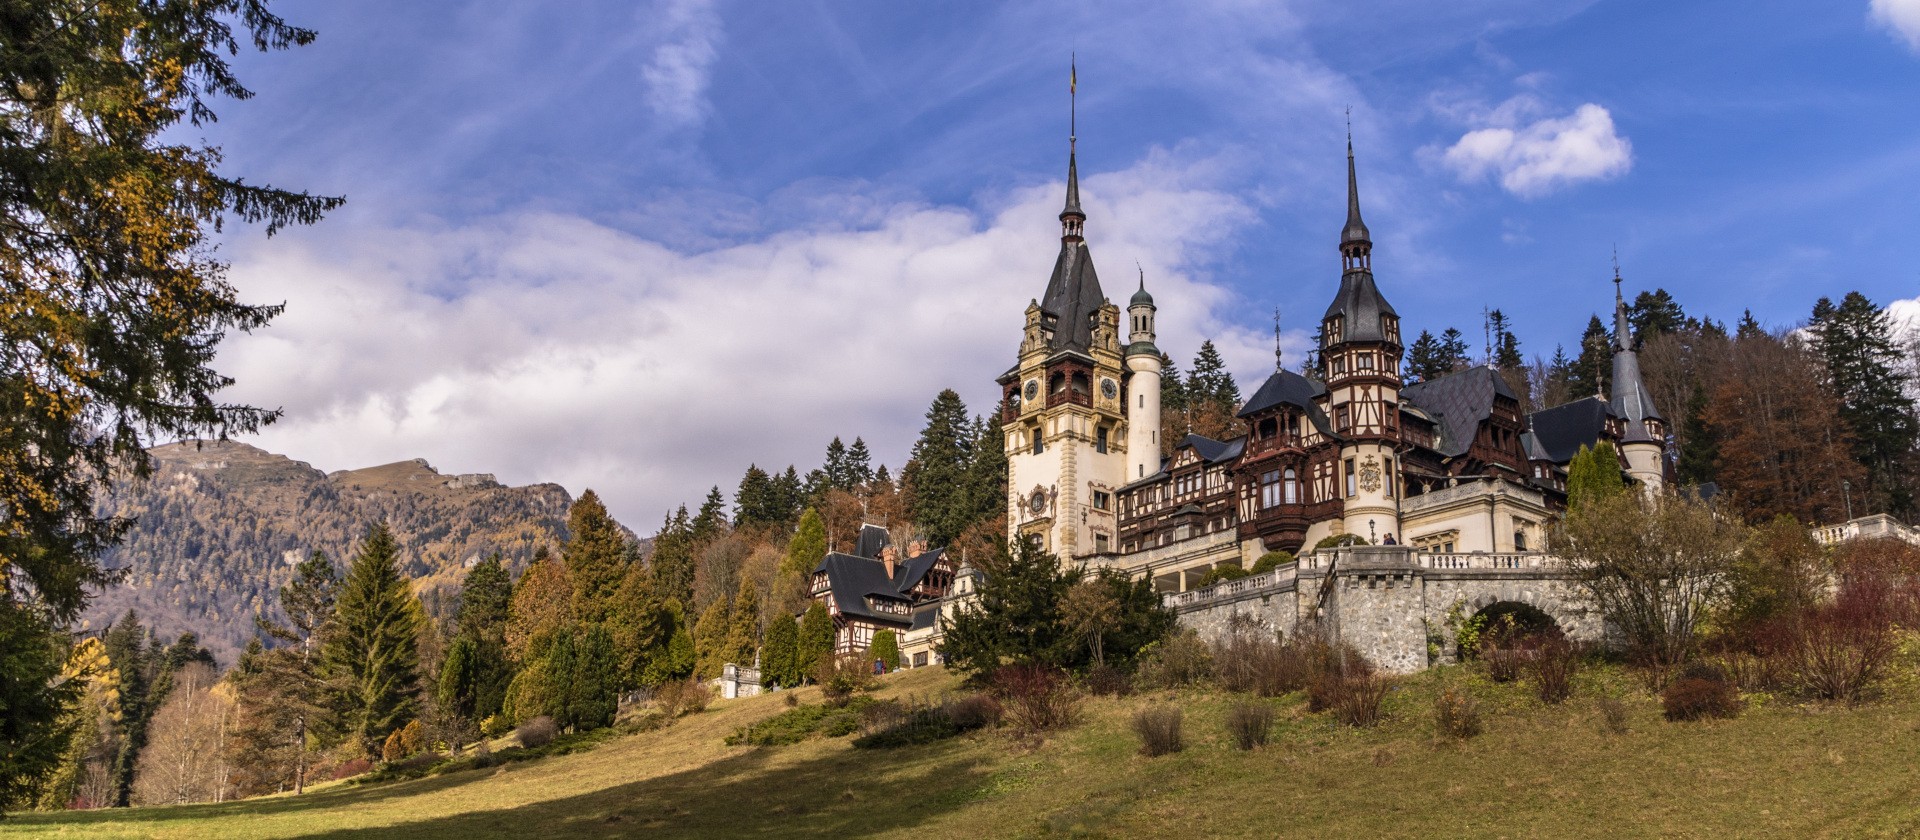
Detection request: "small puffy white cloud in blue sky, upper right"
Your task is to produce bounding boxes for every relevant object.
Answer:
[1440,96,1634,198]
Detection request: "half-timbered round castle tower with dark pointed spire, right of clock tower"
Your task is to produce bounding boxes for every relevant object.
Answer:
[1319,138,1404,539]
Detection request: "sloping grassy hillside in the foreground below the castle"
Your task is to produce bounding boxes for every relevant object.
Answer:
[0,669,1920,840]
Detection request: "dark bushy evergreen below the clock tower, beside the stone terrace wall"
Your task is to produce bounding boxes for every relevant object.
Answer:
[941,539,1079,683]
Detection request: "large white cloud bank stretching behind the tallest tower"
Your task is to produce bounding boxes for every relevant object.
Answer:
[219,155,1259,531]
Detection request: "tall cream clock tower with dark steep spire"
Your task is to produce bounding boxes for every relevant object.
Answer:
[998,150,1127,560]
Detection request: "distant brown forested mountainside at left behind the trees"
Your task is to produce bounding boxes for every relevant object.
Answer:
[86,441,606,664]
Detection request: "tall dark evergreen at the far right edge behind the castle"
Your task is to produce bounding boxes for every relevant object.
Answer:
[1811,292,1920,514]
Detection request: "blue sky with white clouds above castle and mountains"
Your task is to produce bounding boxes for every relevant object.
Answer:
[200,0,1920,529]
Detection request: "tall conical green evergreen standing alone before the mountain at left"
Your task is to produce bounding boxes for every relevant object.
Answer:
[323,524,424,754]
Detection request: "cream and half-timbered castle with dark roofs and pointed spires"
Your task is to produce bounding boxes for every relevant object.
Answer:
[998,142,1668,593]
